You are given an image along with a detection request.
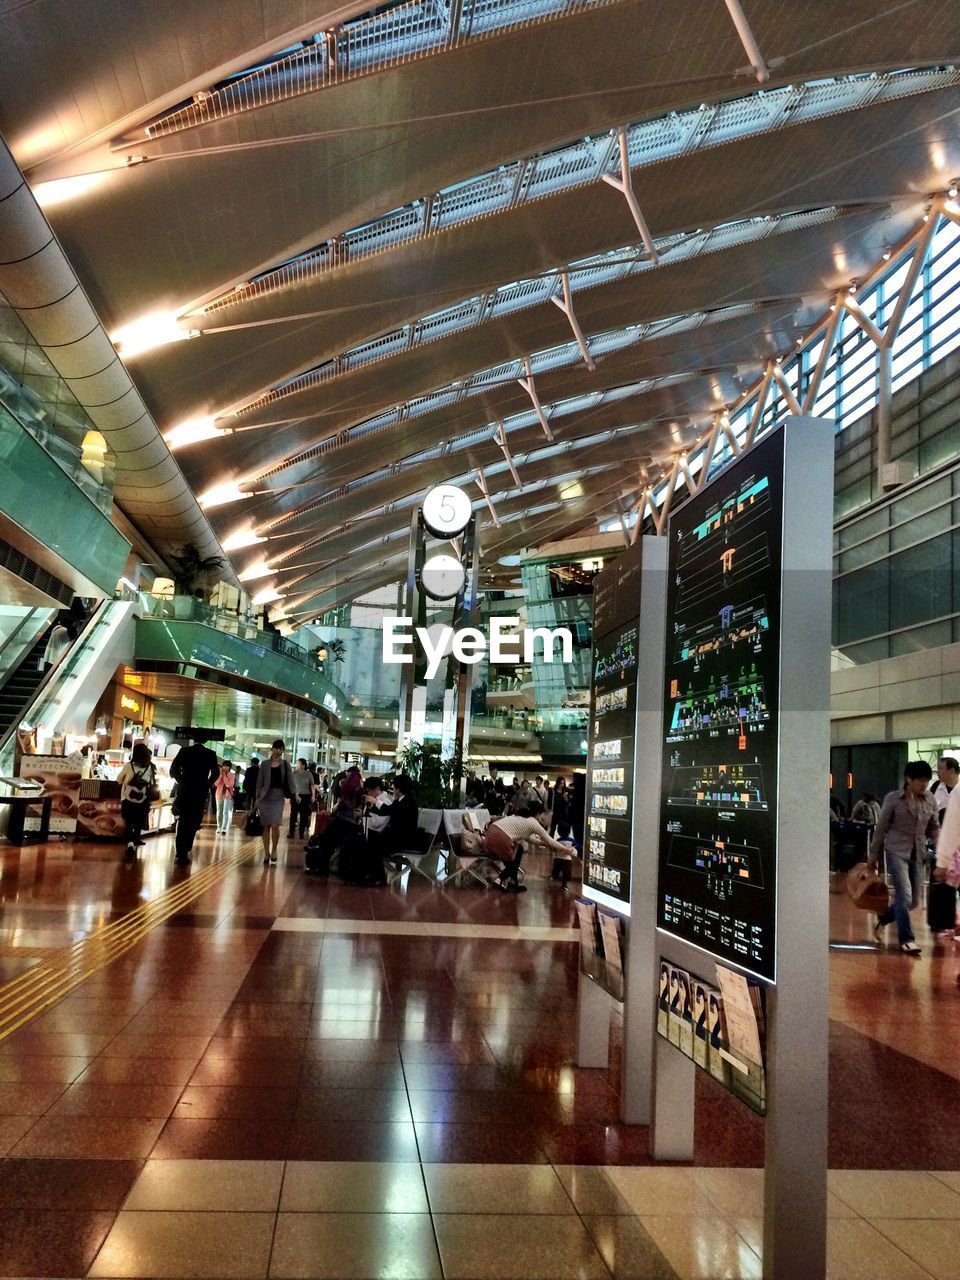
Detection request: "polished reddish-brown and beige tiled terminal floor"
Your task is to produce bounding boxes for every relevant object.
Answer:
[0,831,960,1280]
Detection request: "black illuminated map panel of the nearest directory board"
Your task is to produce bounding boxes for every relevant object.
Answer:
[658,431,783,982]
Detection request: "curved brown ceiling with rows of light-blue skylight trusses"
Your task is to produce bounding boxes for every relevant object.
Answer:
[0,0,960,617]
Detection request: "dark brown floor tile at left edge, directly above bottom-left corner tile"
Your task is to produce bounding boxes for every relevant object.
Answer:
[0,1158,142,1211]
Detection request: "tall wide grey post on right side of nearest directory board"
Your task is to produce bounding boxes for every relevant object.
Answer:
[763,417,835,1280]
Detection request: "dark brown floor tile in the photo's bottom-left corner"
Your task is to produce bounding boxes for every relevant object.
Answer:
[0,1206,114,1276]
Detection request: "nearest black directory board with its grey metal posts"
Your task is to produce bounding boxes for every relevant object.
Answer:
[650,417,835,1280]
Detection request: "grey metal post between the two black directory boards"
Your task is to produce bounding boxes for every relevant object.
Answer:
[624,538,670,1124]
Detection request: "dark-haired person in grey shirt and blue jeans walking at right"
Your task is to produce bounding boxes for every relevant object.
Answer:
[870,760,940,956]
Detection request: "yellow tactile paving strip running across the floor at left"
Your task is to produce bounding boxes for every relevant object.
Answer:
[0,842,260,1041]
